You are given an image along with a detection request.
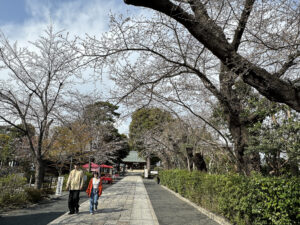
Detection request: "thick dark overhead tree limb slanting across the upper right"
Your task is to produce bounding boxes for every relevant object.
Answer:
[124,0,300,112]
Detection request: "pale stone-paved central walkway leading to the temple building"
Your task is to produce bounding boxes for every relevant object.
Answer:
[49,176,159,225]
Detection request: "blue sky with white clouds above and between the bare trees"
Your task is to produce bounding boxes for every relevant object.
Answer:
[0,0,149,133]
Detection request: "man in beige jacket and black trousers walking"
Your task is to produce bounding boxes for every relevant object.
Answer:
[67,163,83,214]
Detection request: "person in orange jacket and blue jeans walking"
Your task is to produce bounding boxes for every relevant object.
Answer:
[86,172,102,214]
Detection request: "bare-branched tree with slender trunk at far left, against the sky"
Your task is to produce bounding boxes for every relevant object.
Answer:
[0,26,81,189]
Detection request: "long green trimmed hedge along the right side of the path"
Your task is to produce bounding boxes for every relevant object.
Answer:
[160,170,300,225]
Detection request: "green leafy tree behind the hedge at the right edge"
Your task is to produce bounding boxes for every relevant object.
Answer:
[247,107,300,176]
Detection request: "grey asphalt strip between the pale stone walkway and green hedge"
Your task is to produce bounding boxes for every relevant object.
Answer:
[144,179,219,225]
